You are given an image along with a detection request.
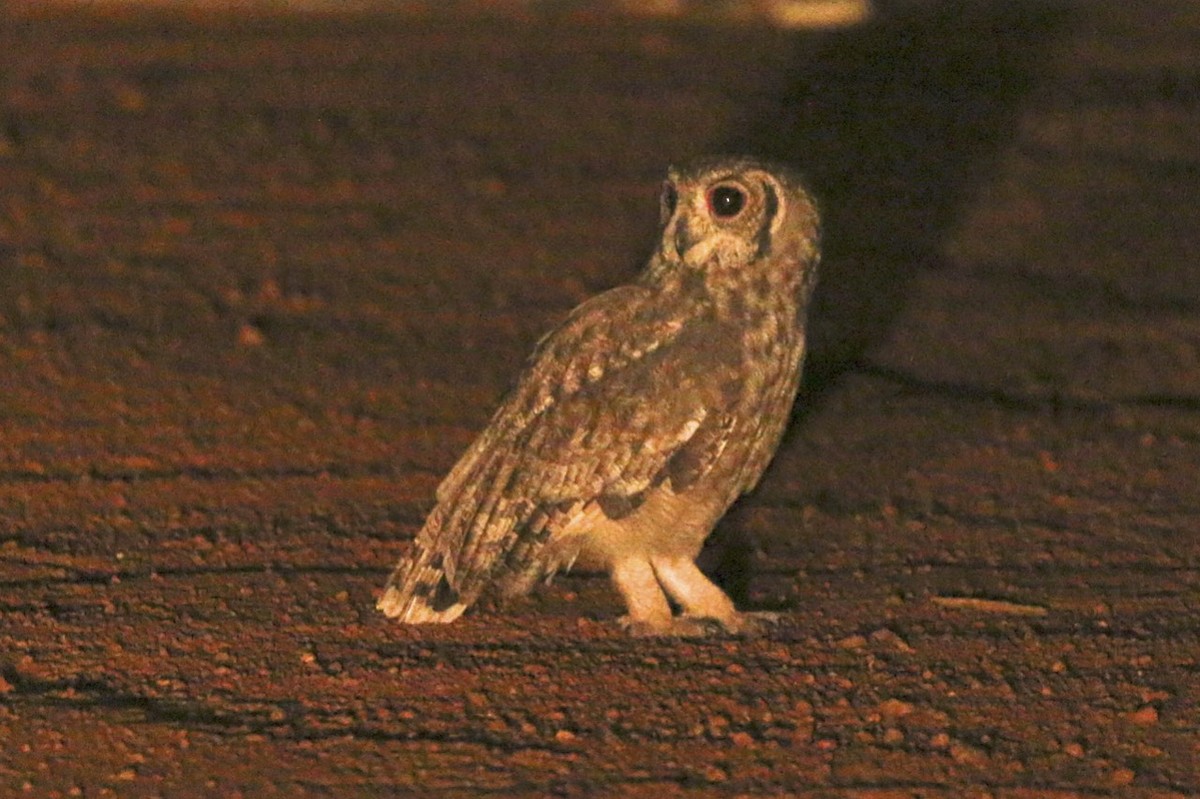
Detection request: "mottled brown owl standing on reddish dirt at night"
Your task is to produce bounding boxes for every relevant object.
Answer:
[378,157,820,635]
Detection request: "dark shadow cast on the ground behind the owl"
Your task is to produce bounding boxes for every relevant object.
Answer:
[702,0,1068,603]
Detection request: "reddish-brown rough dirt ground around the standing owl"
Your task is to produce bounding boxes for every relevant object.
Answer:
[0,0,1200,799]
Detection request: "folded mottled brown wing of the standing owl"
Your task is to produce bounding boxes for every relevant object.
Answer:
[384,286,740,612]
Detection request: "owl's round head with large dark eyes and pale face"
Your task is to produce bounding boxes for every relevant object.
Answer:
[659,157,818,271]
